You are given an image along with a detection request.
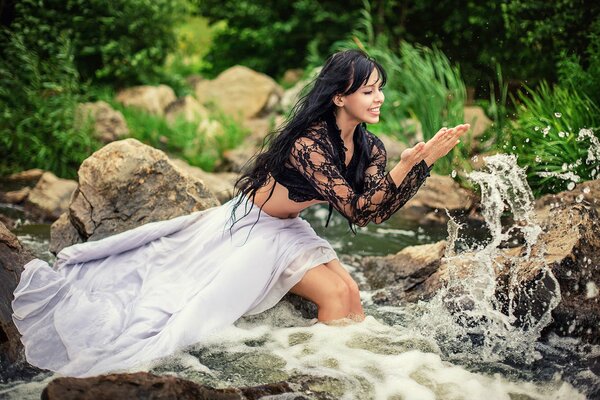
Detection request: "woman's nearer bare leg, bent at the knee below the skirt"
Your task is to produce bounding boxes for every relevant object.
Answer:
[290,264,351,322]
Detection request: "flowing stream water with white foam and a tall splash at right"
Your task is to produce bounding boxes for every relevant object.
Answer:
[0,155,600,400]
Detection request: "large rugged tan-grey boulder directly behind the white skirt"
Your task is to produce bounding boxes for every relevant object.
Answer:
[50,139,219,250]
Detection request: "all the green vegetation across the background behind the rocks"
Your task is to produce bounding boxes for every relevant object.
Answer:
[0,0,600,194]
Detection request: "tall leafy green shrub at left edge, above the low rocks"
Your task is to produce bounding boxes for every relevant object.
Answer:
[0,34,99,178]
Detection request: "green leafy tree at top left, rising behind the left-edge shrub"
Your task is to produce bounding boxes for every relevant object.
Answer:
[0,0,183,86]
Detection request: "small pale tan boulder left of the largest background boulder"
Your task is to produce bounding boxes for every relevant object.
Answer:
[117,85,177,115]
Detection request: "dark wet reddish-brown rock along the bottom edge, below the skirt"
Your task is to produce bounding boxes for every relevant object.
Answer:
[42,372,294,400]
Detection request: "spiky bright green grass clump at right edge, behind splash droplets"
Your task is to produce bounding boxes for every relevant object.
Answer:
[504,82,600,195]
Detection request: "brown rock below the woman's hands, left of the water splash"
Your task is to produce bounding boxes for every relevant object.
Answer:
[398,174,475,223]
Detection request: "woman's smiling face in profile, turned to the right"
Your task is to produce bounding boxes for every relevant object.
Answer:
[340,68,385,124]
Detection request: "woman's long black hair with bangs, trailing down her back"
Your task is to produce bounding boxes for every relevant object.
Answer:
[227,50,387,230]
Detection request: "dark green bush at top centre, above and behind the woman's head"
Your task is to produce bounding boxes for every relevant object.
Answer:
[198,0,360,77]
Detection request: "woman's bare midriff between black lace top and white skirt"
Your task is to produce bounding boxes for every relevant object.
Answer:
[254,177,326,218]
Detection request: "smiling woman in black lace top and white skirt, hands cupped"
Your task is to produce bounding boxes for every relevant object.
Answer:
[13,51,468,376]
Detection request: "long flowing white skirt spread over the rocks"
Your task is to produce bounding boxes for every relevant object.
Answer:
[12,201,337,376]
